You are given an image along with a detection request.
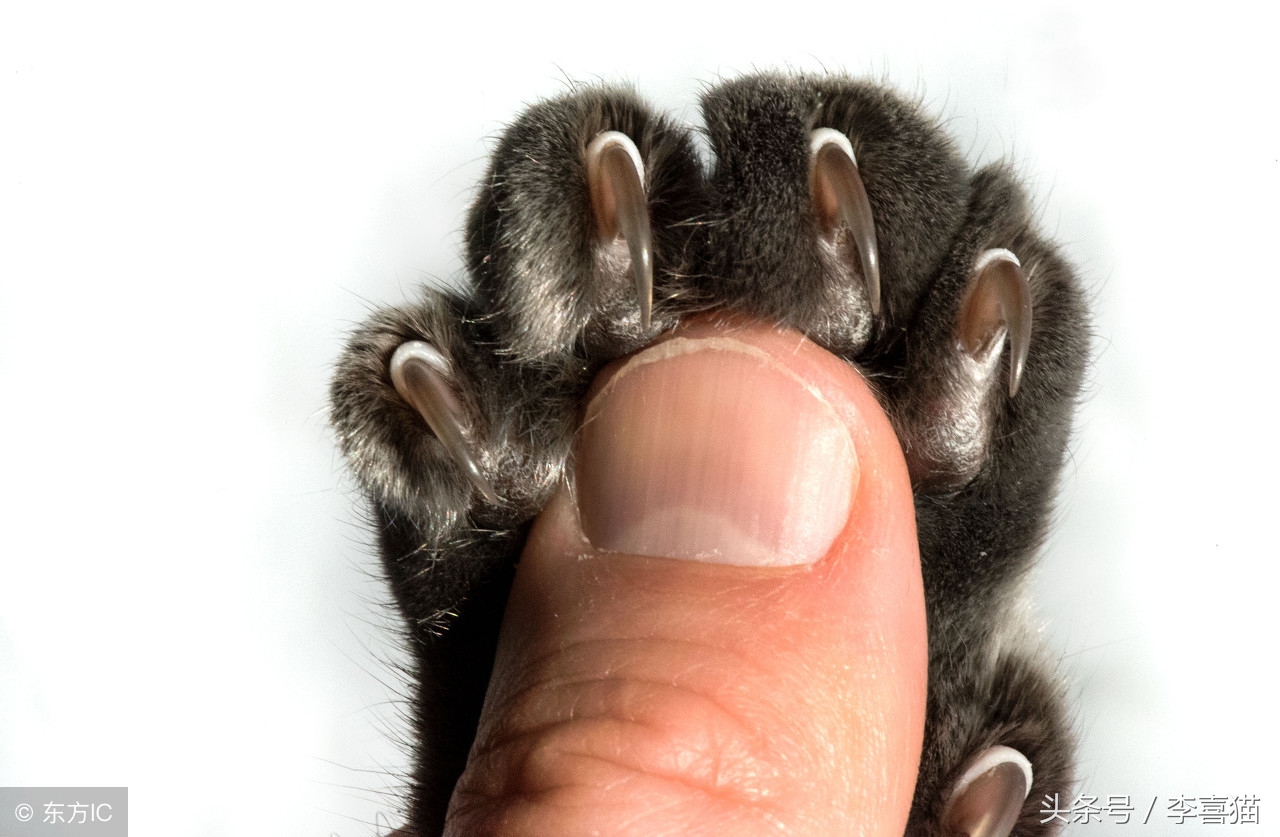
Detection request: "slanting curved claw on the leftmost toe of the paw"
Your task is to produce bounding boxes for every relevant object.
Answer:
[390,340,498,503]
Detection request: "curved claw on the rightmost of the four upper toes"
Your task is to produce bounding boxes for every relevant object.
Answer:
[957,250,1032,398]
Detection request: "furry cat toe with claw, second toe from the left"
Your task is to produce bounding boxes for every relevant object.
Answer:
[467,87,703,367]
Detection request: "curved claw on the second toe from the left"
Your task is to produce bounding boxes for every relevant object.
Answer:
[586,131,653,329]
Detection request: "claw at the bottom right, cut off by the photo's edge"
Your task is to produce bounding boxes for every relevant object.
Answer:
[942,746,1032,837]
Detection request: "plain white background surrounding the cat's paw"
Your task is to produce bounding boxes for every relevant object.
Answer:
[0,0,1280,837]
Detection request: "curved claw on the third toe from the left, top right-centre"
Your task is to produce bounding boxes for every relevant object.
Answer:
[809,128,879,315]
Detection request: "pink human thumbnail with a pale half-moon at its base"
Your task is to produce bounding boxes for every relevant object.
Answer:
[576,337,859,567]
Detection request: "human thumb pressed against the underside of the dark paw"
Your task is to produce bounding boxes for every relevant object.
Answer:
[447,321,927,837]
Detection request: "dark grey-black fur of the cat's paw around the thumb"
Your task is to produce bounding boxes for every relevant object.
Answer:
[333,74,1088,837]
